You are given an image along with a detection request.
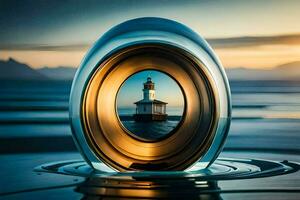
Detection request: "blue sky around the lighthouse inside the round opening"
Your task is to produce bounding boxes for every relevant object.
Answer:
[117,70,184,109]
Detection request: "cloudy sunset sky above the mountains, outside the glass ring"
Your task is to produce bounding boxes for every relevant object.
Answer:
[0,0,300,69]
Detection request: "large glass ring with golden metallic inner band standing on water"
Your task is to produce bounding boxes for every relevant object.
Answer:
[70,17,231,171]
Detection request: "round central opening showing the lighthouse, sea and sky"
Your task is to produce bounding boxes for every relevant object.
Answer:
[116,70,184,140]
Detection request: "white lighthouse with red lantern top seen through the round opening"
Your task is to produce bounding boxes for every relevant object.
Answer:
[134,77,168,121]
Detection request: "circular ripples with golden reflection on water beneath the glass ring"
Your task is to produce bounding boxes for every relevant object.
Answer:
[35,158,300,199]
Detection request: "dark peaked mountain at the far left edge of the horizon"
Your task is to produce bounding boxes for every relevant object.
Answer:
[0,58,47,80]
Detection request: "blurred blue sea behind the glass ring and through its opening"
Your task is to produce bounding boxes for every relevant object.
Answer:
[0,81,300,153]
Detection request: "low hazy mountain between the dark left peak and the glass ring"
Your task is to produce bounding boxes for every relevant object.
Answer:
[37,67,76,80]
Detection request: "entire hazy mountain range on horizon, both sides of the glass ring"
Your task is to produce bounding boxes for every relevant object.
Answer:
[0,58,300,81]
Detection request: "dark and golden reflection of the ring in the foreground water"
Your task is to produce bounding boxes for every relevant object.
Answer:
[76,177,222,200]
